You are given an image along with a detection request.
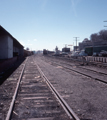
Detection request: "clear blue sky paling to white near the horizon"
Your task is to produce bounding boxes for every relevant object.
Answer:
[0,0,107,50]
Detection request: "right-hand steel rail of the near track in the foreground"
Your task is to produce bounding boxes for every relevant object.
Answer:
[34,61,80,120]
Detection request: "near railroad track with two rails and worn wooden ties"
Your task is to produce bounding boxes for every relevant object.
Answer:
[5,57,80,120]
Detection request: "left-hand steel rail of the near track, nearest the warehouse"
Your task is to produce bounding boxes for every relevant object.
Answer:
[5,58,28,120]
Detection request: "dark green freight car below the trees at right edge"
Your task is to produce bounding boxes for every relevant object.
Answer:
[85,45,107,56]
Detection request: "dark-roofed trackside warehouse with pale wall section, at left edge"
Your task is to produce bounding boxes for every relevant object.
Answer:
[0,26,24,59]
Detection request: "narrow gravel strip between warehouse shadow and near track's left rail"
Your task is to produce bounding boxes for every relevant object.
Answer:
[0,62,24,120]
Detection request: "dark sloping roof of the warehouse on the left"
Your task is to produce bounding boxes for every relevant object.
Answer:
[0,25,24,48]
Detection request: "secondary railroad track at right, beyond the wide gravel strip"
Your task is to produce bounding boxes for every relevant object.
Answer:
[42,55,107,84]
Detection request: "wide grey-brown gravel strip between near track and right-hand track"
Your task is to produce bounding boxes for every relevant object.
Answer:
[35,56,107,120]
